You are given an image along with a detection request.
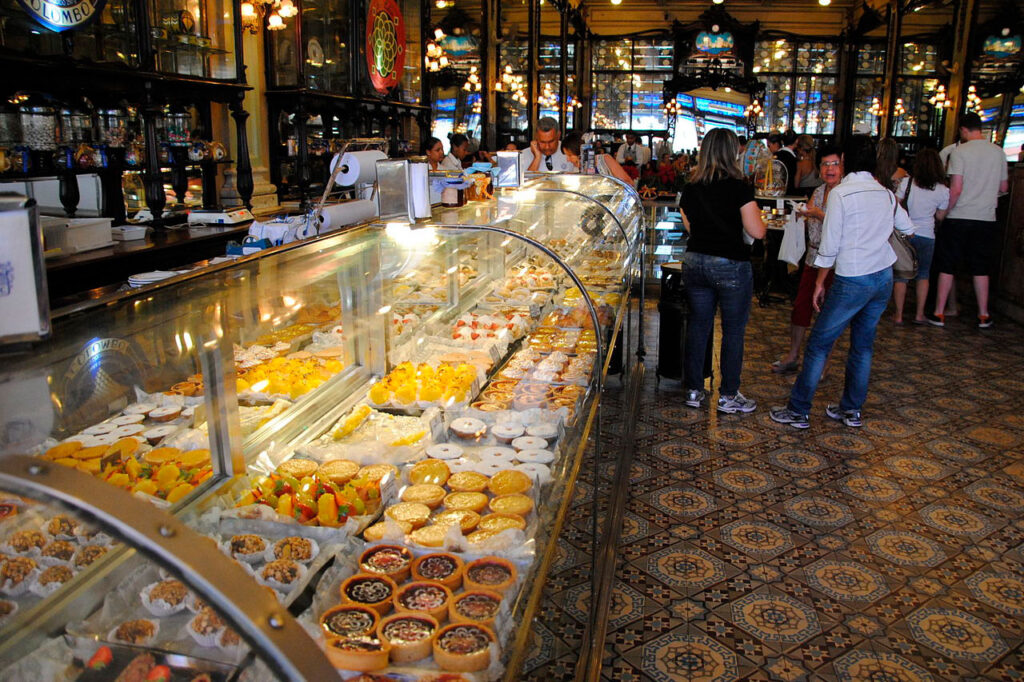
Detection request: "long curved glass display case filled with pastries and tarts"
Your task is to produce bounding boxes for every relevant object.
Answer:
[0,176,643,680]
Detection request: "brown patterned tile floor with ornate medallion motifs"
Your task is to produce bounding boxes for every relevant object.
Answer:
[523,294,1024,682]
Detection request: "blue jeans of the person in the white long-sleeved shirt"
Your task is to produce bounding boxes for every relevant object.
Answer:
[790,267,893,415]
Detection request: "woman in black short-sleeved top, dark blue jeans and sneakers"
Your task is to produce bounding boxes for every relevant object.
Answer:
[680,128,765,414]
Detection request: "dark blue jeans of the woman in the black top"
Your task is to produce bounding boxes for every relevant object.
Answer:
[683,252,754,395]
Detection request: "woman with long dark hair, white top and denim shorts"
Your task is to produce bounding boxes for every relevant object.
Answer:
[893,147,949,325]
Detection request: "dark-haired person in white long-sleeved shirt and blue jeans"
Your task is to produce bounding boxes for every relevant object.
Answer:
[769,135,913,429]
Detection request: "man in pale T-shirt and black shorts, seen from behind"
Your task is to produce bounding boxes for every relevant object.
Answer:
[928,112,1010,329]
